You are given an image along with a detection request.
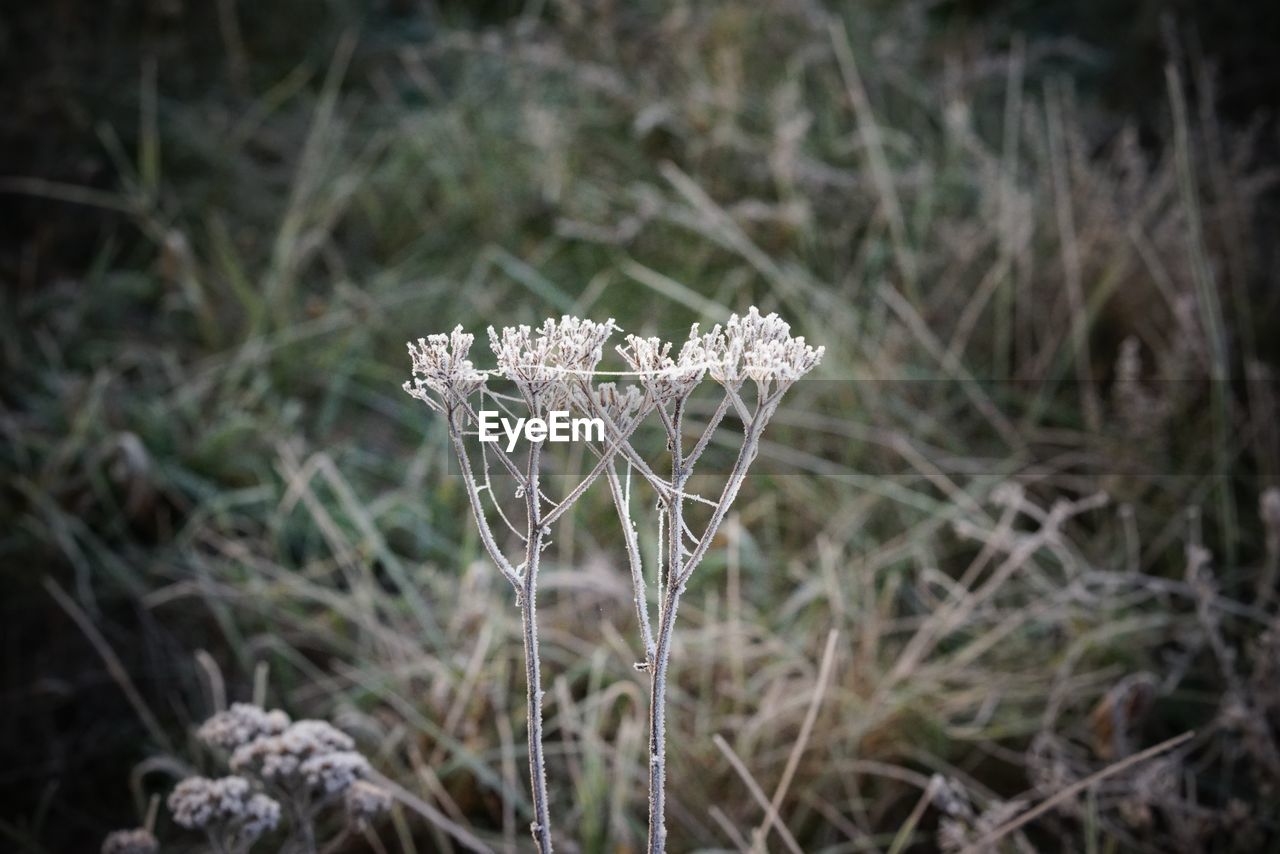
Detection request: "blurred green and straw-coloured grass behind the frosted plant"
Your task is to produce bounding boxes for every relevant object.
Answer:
[0,0,1280,853]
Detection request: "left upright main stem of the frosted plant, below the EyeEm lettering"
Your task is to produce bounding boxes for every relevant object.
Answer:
[520,442,552,854]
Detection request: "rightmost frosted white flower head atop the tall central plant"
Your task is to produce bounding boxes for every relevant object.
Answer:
[703,306,826,393]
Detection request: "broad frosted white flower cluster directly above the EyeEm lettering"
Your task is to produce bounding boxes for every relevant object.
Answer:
[489,315,617,411]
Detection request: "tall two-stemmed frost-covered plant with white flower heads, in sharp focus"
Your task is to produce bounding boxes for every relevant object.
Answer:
[404,307,823,854]
